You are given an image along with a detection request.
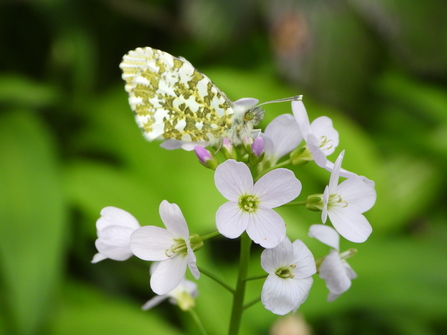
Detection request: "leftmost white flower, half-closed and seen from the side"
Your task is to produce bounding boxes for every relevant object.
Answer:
[92,207,140,263]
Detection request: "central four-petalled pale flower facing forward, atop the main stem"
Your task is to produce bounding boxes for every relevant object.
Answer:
[214,160,301,248]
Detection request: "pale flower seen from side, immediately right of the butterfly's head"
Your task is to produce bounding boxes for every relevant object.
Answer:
[261,114,303,165]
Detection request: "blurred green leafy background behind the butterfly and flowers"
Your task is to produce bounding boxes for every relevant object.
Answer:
[0,0,447,335]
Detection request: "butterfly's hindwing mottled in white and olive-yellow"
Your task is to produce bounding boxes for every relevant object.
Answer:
[120,47,234,142]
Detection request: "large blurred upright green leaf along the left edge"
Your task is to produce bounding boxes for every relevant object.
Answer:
[0,112,66,335]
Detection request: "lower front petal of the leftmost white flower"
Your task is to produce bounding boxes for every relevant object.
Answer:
[95,226,134,261]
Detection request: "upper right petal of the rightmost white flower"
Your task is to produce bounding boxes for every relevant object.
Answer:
[335,177,377,213]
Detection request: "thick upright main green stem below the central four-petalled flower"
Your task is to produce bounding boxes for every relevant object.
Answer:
[228,232,251,335]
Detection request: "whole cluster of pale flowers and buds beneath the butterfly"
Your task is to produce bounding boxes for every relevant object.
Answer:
[92,100,376,326]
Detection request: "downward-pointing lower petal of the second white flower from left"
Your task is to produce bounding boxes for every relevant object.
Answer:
[151,256,187,295]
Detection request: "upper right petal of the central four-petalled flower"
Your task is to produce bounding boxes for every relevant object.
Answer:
[253,169,302,208]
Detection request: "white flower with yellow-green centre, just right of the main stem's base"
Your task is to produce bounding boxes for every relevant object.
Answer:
[261,237,316,315]
